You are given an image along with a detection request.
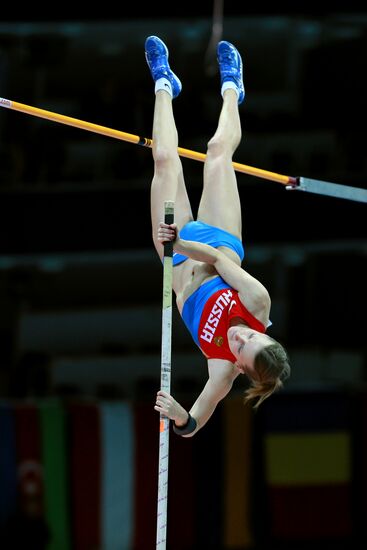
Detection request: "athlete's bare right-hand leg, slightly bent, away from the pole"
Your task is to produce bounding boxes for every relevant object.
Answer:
[198,89,242,238]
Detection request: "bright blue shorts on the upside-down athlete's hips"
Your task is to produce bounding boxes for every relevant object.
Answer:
[173,221,245,265]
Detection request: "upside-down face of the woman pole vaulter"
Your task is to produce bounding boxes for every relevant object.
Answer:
[227,325,273,380]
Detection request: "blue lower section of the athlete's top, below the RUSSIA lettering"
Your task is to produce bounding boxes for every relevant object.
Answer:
[182,276,229,347]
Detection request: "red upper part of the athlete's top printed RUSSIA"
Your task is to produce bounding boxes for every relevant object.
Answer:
[198,288,266,363]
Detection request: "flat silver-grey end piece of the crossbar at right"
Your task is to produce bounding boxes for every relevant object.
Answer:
[286,177,367,203]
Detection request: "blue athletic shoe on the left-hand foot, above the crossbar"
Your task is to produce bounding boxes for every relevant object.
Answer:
[145,36,182,97]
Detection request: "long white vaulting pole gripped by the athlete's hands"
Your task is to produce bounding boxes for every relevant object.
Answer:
[156,201,174,550]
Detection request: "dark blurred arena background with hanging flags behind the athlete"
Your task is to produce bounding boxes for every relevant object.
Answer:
[0,4,367,550]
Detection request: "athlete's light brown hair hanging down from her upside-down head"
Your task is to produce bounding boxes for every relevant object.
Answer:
[244,342,291,409]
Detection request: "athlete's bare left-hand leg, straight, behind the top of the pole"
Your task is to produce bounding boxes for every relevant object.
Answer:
[151,90,193,258]
